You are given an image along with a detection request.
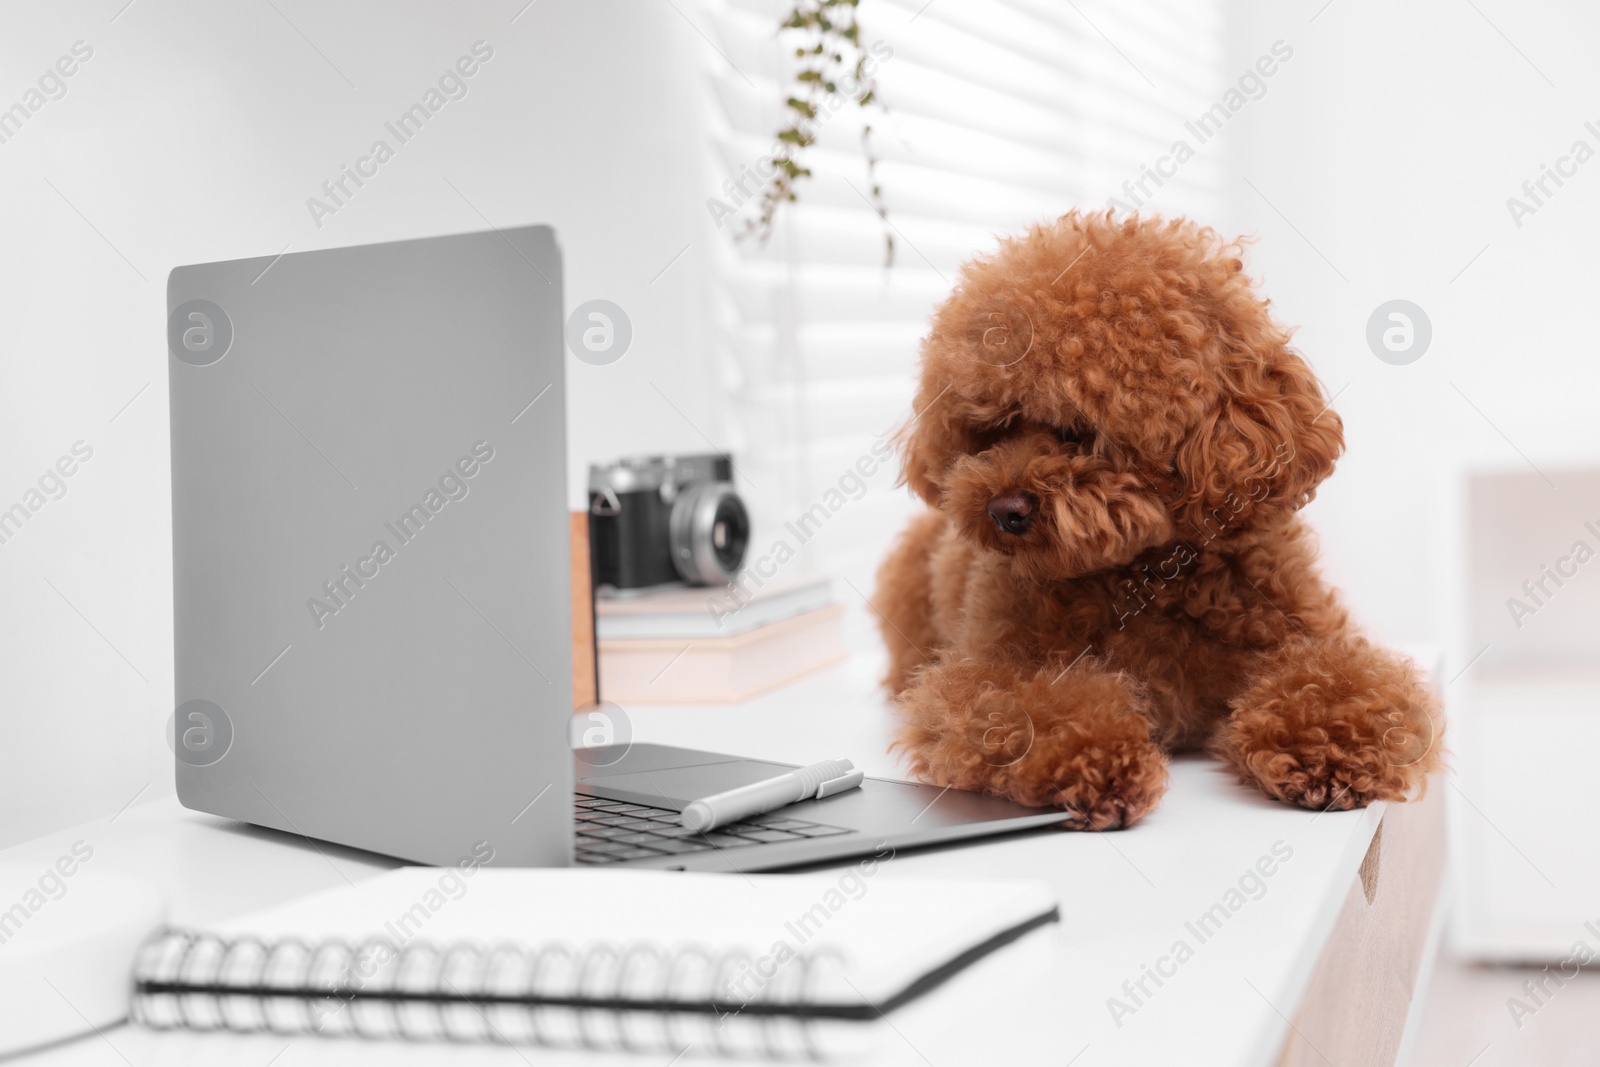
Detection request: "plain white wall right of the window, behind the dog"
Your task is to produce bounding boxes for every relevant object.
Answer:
[1224,0,1600,652]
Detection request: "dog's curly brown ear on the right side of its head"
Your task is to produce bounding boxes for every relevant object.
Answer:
[1176,339,1344,536]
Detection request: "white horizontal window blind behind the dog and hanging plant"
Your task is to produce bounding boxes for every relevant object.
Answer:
[696,0,1229,627]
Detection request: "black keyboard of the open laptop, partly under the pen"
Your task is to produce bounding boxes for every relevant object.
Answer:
[573,793,851,864]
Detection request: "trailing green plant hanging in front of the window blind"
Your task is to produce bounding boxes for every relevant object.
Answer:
[742,0,894,267]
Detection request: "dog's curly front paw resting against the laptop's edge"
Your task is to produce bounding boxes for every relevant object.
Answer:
[899,661,1166,830]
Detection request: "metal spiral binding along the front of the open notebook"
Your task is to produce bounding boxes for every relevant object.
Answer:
[131,928,830,1059]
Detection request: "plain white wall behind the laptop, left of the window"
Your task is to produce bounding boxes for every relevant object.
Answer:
[0,0,720,845]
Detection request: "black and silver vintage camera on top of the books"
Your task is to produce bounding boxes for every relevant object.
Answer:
[589,454,750,589]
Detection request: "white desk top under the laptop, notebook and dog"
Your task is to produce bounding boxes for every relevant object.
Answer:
[0,661,1437,1067]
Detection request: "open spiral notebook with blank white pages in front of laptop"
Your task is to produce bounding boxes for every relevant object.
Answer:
[133,859,1059,1057]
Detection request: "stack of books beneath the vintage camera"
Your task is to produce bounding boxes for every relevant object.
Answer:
[595,577,845,704]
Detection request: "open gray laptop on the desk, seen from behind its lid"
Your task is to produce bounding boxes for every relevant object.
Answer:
[166,227,1064,870]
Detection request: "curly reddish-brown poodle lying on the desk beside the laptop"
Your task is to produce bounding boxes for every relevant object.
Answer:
[874,213,1443,830]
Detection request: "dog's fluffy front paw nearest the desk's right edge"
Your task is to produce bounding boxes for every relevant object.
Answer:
[1213,638,1443,811]
